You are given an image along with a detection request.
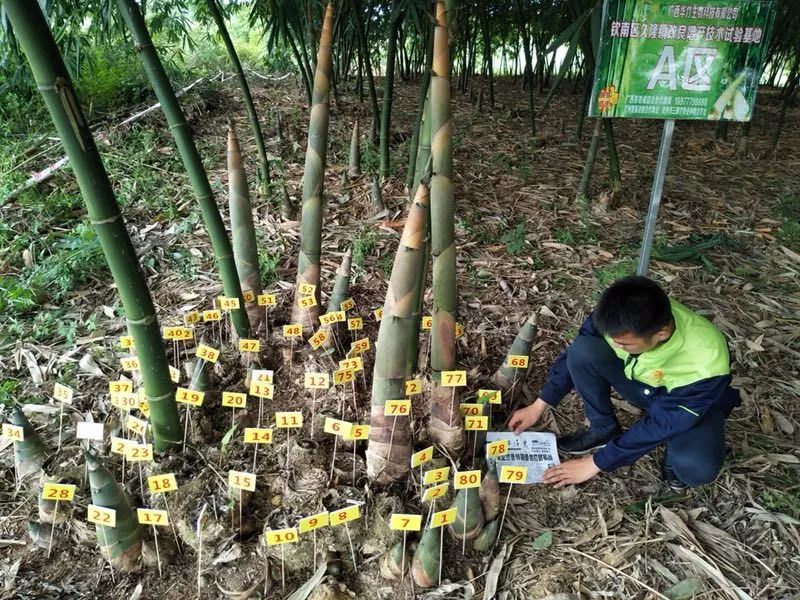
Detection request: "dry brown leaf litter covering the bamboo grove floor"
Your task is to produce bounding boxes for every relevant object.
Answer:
[0,72,800,599]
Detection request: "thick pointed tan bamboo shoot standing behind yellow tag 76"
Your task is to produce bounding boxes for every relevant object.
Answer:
[367,183,429,485]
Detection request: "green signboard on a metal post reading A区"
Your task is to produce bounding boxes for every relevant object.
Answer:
[589,0,775,121]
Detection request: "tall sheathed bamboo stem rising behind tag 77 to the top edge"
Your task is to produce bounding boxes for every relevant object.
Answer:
[428,0,465,456]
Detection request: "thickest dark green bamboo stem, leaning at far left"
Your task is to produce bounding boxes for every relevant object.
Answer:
[3,0,182,451]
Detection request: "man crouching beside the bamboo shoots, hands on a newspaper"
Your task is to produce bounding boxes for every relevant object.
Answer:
[509,277,740,491]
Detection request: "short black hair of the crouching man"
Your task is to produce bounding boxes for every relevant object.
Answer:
[592,275,672,337]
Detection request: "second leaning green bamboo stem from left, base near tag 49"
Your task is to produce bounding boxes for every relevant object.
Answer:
[117,0,250,338]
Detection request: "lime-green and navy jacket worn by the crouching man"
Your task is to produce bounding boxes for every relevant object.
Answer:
[539,301,740,471]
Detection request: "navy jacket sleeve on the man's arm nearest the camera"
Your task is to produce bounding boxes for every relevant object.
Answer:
[594,375,731,472]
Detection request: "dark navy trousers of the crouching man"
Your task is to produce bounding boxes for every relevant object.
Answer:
[567,335,727,487]
